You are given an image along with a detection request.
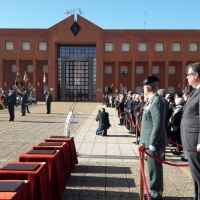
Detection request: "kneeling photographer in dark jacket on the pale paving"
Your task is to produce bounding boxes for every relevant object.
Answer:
[96,108,110,136]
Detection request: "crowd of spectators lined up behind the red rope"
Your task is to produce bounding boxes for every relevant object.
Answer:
[102,89,190,161]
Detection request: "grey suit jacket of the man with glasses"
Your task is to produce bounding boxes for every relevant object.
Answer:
[181,88,200,151]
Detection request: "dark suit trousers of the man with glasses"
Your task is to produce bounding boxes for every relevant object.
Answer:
[187,151,200,200]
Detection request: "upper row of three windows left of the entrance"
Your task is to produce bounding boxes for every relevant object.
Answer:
[5,41,47,51]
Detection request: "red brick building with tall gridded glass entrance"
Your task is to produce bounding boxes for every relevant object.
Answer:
[0,15,200,101]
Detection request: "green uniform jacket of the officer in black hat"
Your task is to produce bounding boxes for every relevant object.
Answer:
[140,94,168,149]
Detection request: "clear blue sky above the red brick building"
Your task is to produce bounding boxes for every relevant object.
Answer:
[0,0,200,29]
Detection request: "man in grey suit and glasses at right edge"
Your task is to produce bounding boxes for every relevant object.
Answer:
[181,62,200,200]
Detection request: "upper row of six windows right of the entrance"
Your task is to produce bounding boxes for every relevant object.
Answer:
[105,42,198,52]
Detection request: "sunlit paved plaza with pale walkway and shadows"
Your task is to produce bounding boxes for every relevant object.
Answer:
[0,102,194,200]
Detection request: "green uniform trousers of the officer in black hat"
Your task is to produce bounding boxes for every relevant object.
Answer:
[147,148,164,198]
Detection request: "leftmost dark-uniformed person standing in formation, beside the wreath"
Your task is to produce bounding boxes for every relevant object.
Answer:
[7,88,16,121]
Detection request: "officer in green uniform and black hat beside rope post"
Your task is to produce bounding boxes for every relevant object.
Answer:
[140,76,168,200]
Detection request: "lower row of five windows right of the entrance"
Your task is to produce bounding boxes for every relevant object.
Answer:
[104,66,182,74]
